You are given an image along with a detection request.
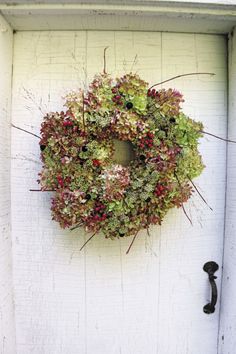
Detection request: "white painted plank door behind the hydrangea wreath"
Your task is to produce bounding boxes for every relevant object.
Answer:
[12,31,227,354]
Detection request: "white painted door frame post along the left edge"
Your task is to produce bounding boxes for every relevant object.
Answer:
[0,15,15,354]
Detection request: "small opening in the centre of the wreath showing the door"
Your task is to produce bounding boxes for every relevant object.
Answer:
[112,139,135,166]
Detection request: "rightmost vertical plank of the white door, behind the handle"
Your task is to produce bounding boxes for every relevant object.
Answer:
[158,33,227,354]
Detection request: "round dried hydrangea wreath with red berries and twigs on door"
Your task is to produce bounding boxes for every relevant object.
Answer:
[12,50,234,252]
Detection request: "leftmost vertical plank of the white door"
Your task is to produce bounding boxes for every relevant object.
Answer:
[12,32,86,354]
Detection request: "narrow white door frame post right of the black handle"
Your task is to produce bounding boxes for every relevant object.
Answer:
[218,31,236,354]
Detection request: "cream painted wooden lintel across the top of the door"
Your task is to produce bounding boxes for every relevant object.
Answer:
[0,0,236,34]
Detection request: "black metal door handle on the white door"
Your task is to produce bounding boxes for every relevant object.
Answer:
[203,262,219,315]
